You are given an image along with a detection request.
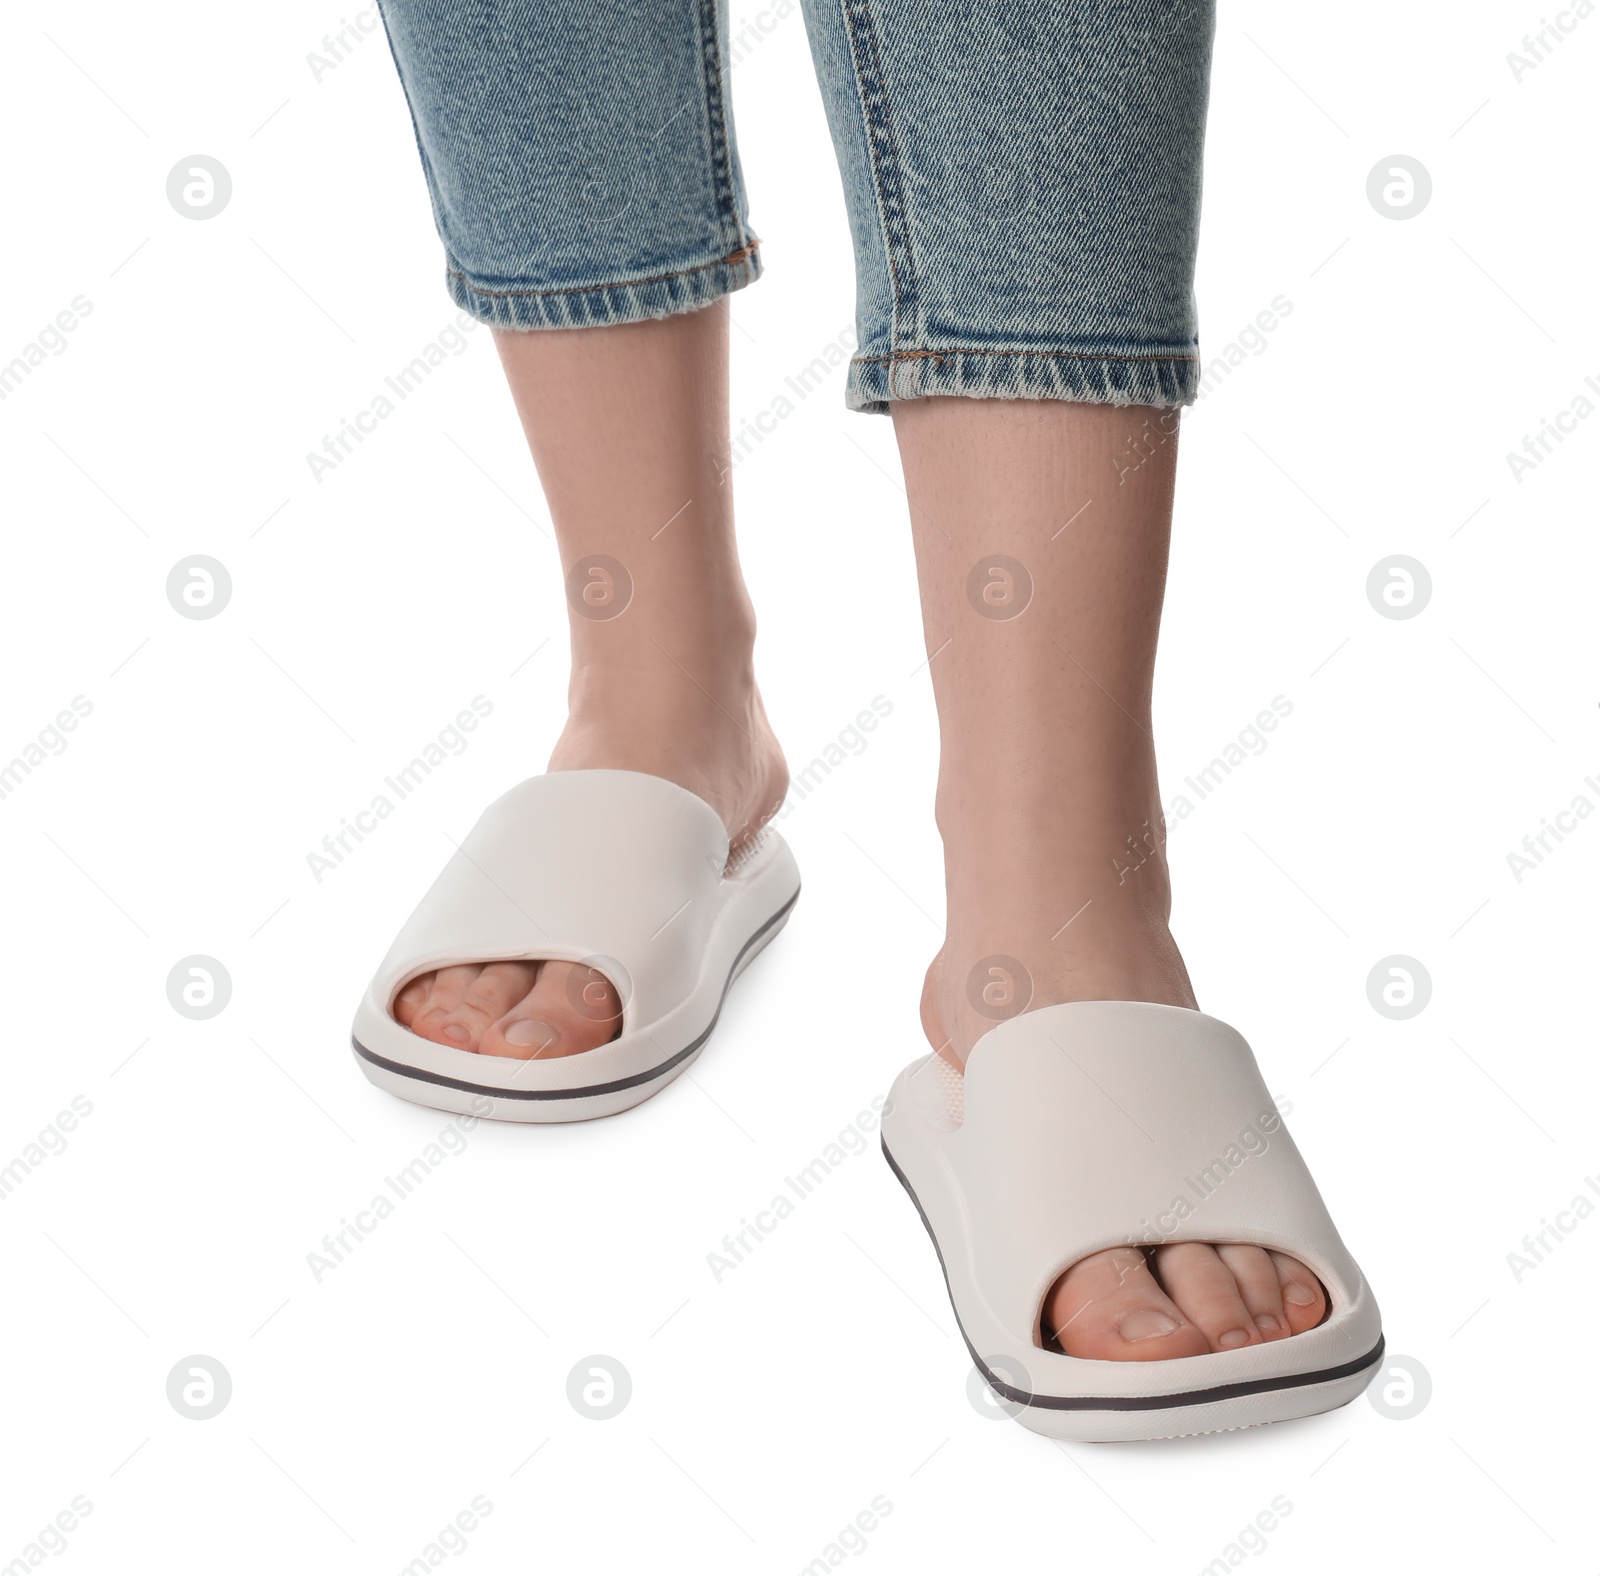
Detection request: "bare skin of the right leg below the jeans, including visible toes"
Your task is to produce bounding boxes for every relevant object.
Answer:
[893,398,1323,1360]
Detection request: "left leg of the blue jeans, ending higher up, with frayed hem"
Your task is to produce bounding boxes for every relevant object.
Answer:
[382,0,760,328]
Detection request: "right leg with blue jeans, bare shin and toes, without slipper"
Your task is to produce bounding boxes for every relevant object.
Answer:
[806,0,1323,1360]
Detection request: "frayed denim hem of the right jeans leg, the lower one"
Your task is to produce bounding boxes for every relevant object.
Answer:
[845,350,1200,416]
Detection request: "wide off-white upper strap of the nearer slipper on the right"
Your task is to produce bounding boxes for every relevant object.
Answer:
[950,1002,1362,1341]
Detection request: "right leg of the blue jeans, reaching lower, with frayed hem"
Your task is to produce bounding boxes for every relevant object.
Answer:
[803,0,1214,411]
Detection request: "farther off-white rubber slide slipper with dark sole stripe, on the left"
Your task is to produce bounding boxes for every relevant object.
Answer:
[352,771,800,1122]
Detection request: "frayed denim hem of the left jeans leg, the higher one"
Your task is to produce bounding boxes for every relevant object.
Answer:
[445,240,762,328]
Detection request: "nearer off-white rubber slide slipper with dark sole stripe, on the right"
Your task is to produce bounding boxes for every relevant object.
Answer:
[883,1002,1384,1442]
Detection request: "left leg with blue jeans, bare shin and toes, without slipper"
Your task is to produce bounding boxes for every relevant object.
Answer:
[369,0,787,1058]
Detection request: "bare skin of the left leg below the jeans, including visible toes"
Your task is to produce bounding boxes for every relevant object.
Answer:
[395,302,789,1058]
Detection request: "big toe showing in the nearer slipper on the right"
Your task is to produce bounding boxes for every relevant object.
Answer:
[1043,1248,1210,1362]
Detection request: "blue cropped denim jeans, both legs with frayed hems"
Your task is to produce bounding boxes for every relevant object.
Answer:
[382,0,1214,411]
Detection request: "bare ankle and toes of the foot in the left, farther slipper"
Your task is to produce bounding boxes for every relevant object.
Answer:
[394,659,789,1061]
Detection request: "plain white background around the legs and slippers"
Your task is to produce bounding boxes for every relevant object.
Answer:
[0,0,1600,1576]
